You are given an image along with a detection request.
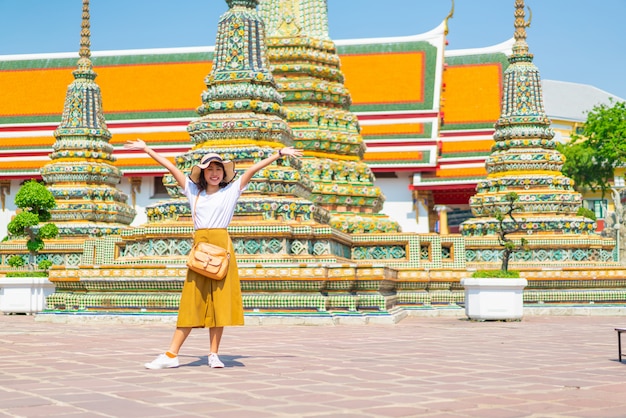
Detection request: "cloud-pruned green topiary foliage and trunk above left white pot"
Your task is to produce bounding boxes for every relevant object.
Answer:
[7,180,59,268]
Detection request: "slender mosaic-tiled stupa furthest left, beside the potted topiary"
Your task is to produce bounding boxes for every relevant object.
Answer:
[41,0,135,237]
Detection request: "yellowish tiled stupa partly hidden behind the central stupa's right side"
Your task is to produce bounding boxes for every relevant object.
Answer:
[259,0,399,233]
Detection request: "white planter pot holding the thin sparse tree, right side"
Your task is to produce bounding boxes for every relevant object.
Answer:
[461,278,528,321]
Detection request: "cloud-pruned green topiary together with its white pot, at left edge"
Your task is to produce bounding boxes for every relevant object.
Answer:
[0,180,59,313]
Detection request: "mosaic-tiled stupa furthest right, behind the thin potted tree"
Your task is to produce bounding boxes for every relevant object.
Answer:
[460,0,612,267]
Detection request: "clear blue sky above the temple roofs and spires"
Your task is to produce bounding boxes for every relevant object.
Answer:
[0,0,626,99]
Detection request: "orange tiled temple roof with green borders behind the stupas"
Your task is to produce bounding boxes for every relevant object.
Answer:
[0,39,504,177]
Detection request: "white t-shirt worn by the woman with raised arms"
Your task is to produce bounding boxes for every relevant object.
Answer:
[183,177,248,229]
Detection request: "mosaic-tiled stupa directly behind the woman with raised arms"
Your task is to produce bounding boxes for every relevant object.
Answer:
[139,0,313,229]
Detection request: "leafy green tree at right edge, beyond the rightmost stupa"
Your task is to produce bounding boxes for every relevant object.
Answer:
[558,99,626,196]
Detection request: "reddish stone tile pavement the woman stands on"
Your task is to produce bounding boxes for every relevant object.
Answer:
[0,315,626,418]
